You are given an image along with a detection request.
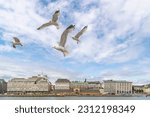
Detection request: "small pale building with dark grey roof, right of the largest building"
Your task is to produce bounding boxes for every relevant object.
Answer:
[55,79,70,91]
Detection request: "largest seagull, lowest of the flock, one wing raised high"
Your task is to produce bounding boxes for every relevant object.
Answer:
[53,25,75,57]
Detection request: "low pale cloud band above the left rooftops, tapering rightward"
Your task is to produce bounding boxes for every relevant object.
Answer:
[0,56,80,82]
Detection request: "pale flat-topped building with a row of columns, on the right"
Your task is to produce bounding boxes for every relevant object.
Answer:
[104,80,132,95]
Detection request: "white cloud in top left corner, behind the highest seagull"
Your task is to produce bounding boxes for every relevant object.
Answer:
[0,0,61,45]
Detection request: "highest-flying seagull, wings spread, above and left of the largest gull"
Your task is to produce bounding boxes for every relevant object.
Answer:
[37,10,60,30]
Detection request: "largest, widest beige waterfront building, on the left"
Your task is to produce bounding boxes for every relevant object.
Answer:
[7,75,52,93]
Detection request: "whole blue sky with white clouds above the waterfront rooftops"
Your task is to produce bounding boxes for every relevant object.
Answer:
[0,0,150,84]
